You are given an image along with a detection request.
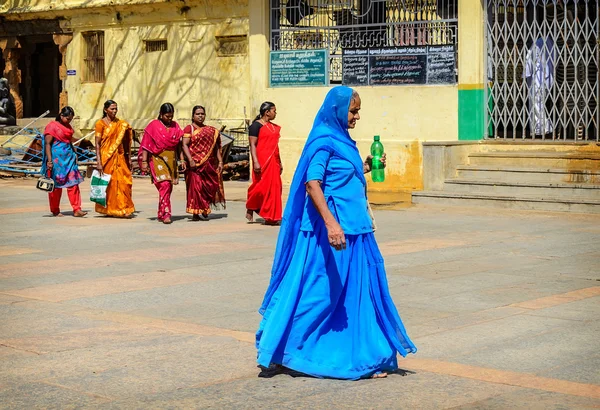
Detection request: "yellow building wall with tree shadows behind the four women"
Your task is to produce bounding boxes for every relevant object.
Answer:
[2,0,251,130]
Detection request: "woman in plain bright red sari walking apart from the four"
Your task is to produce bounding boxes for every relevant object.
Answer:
[246,101,283,225]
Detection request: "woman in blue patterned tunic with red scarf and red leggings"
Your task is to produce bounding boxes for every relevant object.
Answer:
[40,106,87,217]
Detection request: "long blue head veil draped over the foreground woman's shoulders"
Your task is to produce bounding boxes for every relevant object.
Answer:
[259,86,366,314]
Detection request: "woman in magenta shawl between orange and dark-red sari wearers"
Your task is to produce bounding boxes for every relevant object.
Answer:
[138,103,185,224]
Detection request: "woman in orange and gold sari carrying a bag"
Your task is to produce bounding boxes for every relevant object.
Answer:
[95,100,135,218]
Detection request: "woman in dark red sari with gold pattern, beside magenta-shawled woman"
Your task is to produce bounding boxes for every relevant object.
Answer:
[183,105,225,221]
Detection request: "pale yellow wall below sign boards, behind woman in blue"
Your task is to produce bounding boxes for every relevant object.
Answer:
[249,0,458,191]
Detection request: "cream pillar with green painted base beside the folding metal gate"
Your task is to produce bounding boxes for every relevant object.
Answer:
[458,0,486,140]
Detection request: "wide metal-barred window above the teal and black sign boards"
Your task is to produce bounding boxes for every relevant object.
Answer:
[270,0,458,84]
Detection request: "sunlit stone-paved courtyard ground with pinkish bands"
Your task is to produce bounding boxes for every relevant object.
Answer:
[0,179,600,409]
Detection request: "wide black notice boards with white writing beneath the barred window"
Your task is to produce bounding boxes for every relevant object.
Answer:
[342,45,456,86]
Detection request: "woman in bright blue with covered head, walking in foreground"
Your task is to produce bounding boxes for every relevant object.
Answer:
[256,86,417,380]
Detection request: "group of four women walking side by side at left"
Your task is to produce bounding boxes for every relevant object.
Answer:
[41,100,225,224]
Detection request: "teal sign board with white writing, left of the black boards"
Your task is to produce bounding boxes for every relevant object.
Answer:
[269,49,329,87]
